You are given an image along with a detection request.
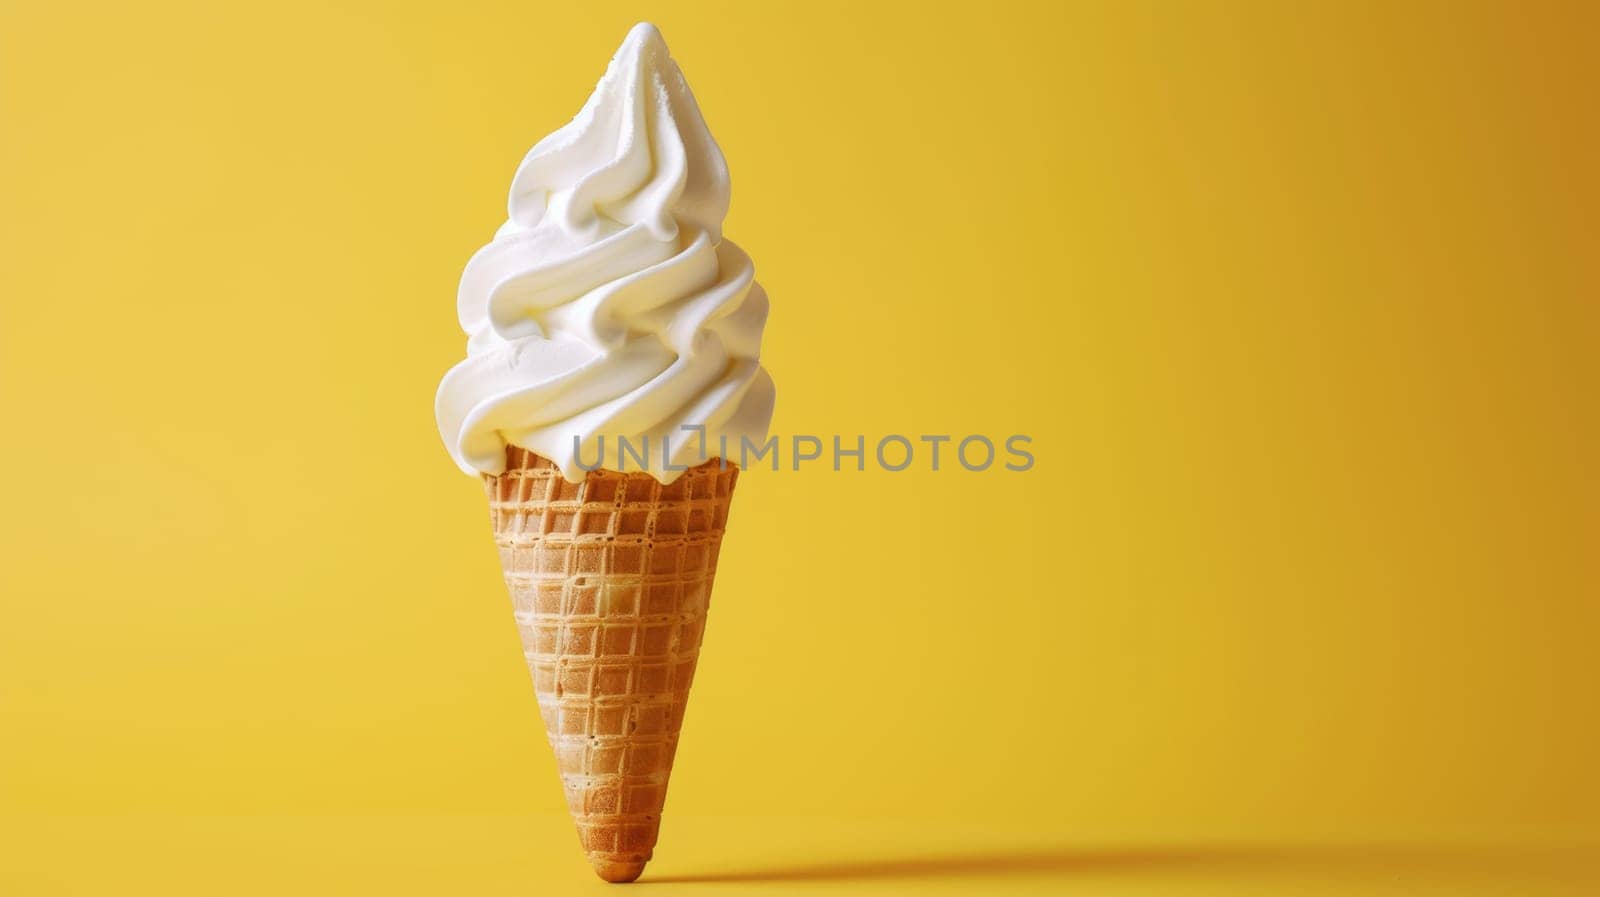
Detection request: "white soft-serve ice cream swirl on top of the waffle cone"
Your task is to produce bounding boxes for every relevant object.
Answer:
[435,24,774,483]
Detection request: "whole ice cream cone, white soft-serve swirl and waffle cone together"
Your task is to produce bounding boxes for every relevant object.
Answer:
[434,22,776,881]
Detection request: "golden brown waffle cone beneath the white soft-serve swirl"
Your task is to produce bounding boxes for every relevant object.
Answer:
[485,446,739,881]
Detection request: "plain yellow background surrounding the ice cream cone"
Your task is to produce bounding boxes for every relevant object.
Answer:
[0,0,1600,895]
